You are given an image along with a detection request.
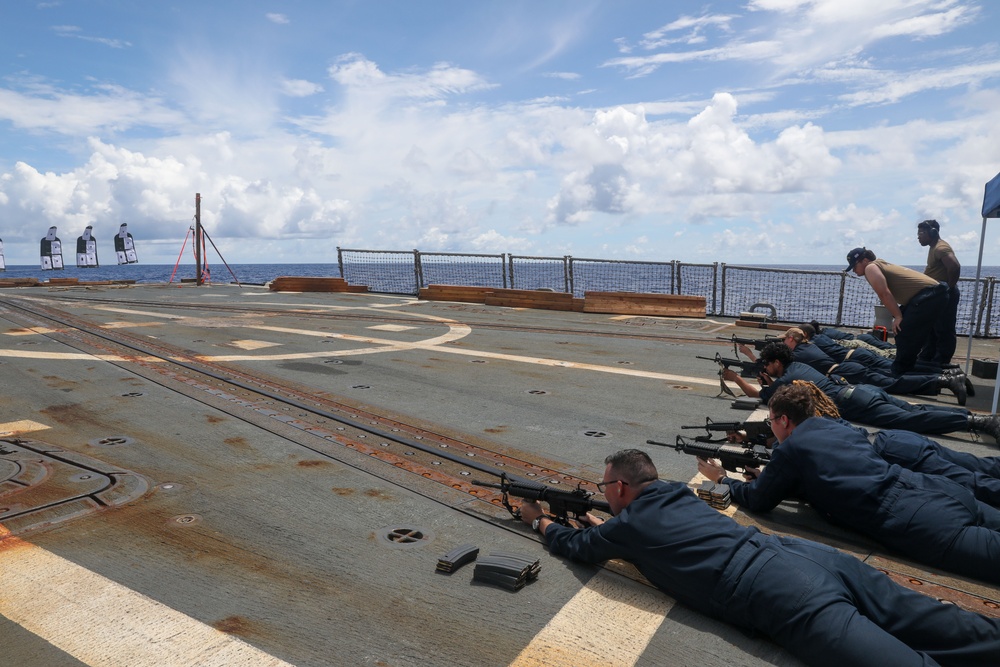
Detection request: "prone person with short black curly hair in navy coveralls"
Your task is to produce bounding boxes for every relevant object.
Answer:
[723,343,1000,439]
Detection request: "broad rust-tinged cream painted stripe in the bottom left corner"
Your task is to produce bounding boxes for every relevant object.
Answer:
[0,526,290,667]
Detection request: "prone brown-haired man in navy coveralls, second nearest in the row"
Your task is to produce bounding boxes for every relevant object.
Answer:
[698,386,1000,584]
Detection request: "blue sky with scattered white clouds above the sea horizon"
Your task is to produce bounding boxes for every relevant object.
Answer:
[0,0,1000,267]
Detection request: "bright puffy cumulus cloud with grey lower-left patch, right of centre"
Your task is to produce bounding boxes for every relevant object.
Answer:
[549,94,840,224]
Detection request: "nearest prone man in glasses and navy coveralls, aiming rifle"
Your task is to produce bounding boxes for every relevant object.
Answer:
[521,450,1000,667]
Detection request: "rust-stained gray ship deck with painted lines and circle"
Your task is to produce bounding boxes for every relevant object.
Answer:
[0,285,1000,667]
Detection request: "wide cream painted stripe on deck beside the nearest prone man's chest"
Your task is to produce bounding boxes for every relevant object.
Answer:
[510,570,674,667]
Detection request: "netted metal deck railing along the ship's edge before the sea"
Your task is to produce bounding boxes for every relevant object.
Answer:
[337,248,1000,338]
